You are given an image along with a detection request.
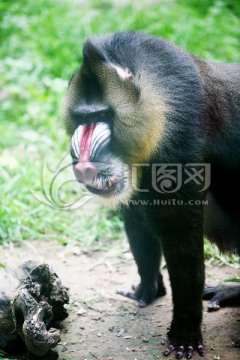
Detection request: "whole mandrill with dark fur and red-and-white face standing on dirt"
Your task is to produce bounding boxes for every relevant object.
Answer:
[65,32,240,359]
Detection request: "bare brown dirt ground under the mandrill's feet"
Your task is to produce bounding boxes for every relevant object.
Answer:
[0,241,240,360]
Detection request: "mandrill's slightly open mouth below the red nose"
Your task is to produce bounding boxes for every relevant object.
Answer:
[84,176,119,197]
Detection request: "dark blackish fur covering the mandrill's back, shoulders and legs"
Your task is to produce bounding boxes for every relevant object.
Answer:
[66,32,240,352]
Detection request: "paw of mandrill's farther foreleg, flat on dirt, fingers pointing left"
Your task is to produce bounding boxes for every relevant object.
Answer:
[117,275,166,307]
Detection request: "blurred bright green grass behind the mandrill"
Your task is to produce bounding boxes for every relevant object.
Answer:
[0,0,240,264]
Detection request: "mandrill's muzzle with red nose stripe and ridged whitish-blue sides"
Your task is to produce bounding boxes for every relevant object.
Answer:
[70,123,120,196]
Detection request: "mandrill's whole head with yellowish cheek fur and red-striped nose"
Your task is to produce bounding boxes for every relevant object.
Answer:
[65,35,168,206]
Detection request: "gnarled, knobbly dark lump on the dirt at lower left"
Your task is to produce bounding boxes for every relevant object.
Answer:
[0,262,69,356]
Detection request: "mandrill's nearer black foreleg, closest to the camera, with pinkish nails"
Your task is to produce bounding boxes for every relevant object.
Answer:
[161,209,204,359]
